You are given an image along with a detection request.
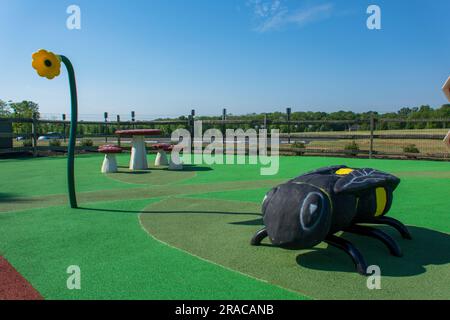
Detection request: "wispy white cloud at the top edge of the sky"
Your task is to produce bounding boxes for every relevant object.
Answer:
[247,0,333,32]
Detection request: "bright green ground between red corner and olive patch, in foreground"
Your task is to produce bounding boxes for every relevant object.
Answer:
[0,199,301,299]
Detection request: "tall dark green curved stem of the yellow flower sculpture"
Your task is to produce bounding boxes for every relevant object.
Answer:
[60,55,78,208]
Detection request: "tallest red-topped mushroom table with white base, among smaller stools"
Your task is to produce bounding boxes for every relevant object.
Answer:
[116,129,161,170]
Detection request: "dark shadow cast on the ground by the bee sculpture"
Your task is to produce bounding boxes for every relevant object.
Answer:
[297,227,450,277]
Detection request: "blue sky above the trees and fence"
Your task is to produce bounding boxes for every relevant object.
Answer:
[0,0,450,116]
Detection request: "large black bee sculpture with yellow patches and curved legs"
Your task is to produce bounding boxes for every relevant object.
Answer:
[251,166,411,275]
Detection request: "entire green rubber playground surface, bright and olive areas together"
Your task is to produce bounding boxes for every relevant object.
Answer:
[0,154,450,299]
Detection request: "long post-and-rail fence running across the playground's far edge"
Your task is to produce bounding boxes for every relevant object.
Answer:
[0,111,450,161]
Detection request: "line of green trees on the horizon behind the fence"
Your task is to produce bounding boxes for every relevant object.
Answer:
[0,99,450,136]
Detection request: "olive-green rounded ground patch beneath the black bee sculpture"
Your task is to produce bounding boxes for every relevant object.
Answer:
[141,198,450,299]
